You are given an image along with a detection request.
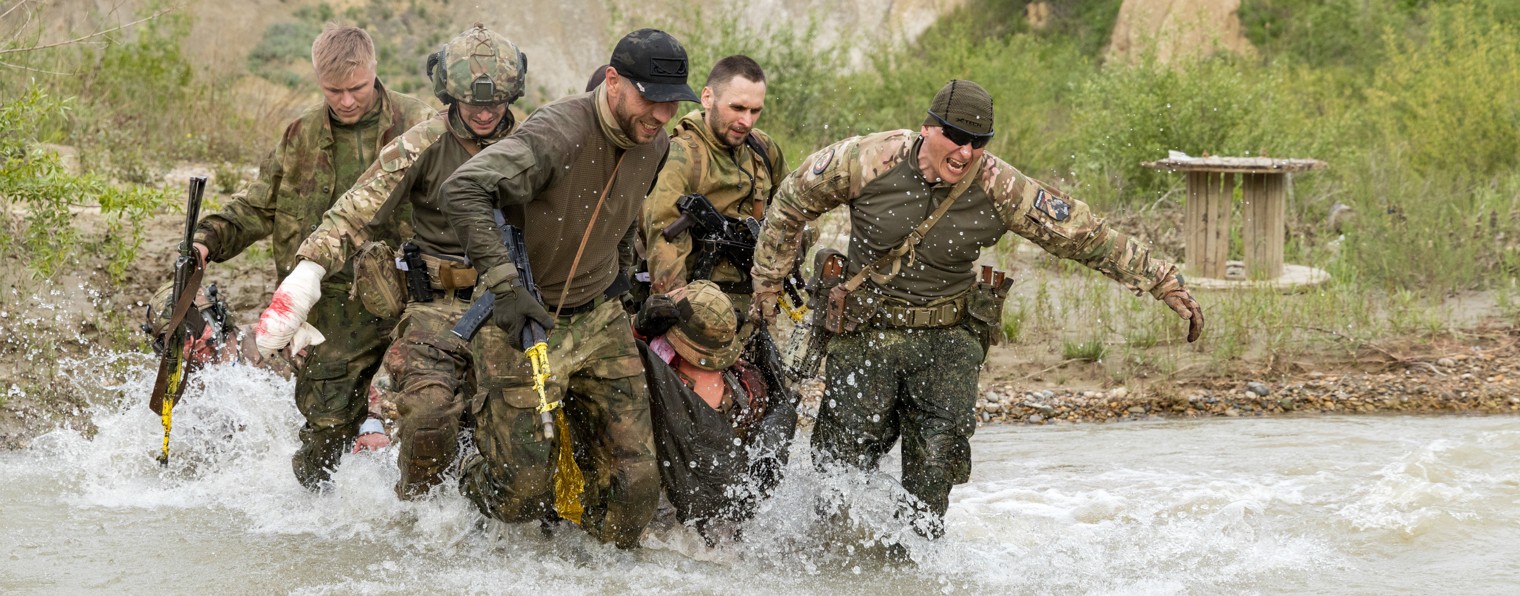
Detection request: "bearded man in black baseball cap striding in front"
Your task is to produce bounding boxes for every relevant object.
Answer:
[442,29,698,547]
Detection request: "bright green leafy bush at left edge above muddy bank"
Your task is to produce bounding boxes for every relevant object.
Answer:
[0,87,167,281]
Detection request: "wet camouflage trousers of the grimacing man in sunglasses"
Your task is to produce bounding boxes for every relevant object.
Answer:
[813,325,982,537]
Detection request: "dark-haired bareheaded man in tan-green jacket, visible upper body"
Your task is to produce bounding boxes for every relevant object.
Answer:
[641,55,787,313]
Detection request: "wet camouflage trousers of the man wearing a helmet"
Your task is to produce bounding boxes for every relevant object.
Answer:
[385,296,474,499]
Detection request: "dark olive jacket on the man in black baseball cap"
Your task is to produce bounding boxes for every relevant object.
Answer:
[442,87,670,312]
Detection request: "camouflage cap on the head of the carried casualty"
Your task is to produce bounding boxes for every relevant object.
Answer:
[666,280,739,371]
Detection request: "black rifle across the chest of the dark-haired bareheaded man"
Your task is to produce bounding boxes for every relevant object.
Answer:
[660,193,807,322]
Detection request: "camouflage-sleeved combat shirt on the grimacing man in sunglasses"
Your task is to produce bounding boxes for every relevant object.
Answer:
[752,131,1176,306]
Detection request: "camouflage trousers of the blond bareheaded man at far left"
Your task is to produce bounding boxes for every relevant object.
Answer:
[290,284,395,490]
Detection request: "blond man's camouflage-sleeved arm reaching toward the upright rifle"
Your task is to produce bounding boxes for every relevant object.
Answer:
[195,143,286,263]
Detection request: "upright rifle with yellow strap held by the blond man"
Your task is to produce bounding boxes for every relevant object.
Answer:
[147,176,205,465]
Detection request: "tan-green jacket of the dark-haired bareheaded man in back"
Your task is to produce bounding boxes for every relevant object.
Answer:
[640,109,787,293]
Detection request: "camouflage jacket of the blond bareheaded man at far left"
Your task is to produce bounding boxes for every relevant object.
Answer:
[195,79,435,281]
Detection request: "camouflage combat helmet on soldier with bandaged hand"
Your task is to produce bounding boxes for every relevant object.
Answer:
[427,23,527,105]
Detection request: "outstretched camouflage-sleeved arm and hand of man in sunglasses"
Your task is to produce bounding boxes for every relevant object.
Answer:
[979,154,1204,342]
